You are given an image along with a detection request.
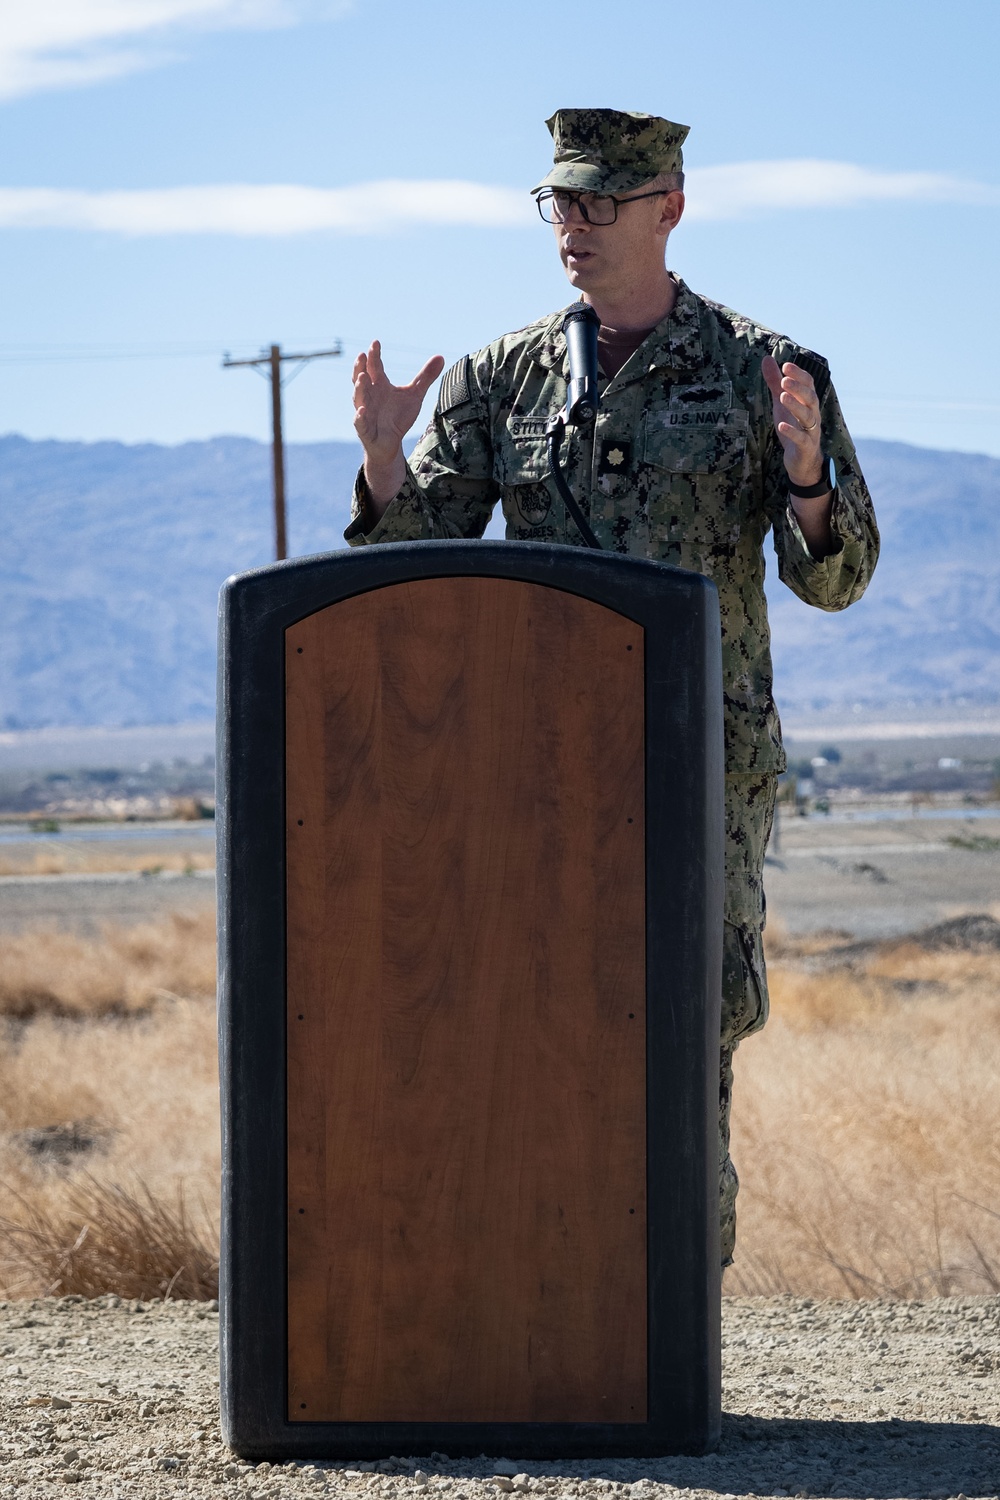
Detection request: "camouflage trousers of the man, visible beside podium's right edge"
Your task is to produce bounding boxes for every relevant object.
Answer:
[718,774,777,1266]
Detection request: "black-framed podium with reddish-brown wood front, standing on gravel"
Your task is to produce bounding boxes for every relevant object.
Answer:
[217,542,723,1458]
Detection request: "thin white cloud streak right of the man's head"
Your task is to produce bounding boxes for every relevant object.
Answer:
[685,158,1000,219]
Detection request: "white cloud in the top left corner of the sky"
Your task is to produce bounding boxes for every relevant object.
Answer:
[0,0,349,99]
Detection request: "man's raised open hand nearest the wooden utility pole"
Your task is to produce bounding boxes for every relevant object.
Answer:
[354,339,444,519]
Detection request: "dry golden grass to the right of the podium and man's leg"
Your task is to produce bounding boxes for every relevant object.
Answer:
[726,924,1000,1298]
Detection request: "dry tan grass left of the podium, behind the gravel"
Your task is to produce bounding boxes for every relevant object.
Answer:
[0,920,219,1298]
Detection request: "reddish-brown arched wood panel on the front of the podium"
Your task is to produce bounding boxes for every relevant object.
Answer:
[285,578,648,1424]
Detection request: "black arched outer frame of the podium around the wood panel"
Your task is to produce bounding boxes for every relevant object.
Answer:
[217,542,723,1458]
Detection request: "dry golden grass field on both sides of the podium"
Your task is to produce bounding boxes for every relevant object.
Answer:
[0,917,1000,1298]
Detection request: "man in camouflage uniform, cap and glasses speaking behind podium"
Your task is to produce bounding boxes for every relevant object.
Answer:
[346,110,879,1265]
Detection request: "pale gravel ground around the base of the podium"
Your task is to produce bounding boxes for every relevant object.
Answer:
[0,1298,1000,1500]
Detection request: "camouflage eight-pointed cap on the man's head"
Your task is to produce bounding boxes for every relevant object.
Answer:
[531,110,690,194]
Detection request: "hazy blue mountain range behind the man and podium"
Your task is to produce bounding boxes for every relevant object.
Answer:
[0,435,1000,729]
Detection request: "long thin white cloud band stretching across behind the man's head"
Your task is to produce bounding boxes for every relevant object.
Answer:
[0,162,1000,237]
